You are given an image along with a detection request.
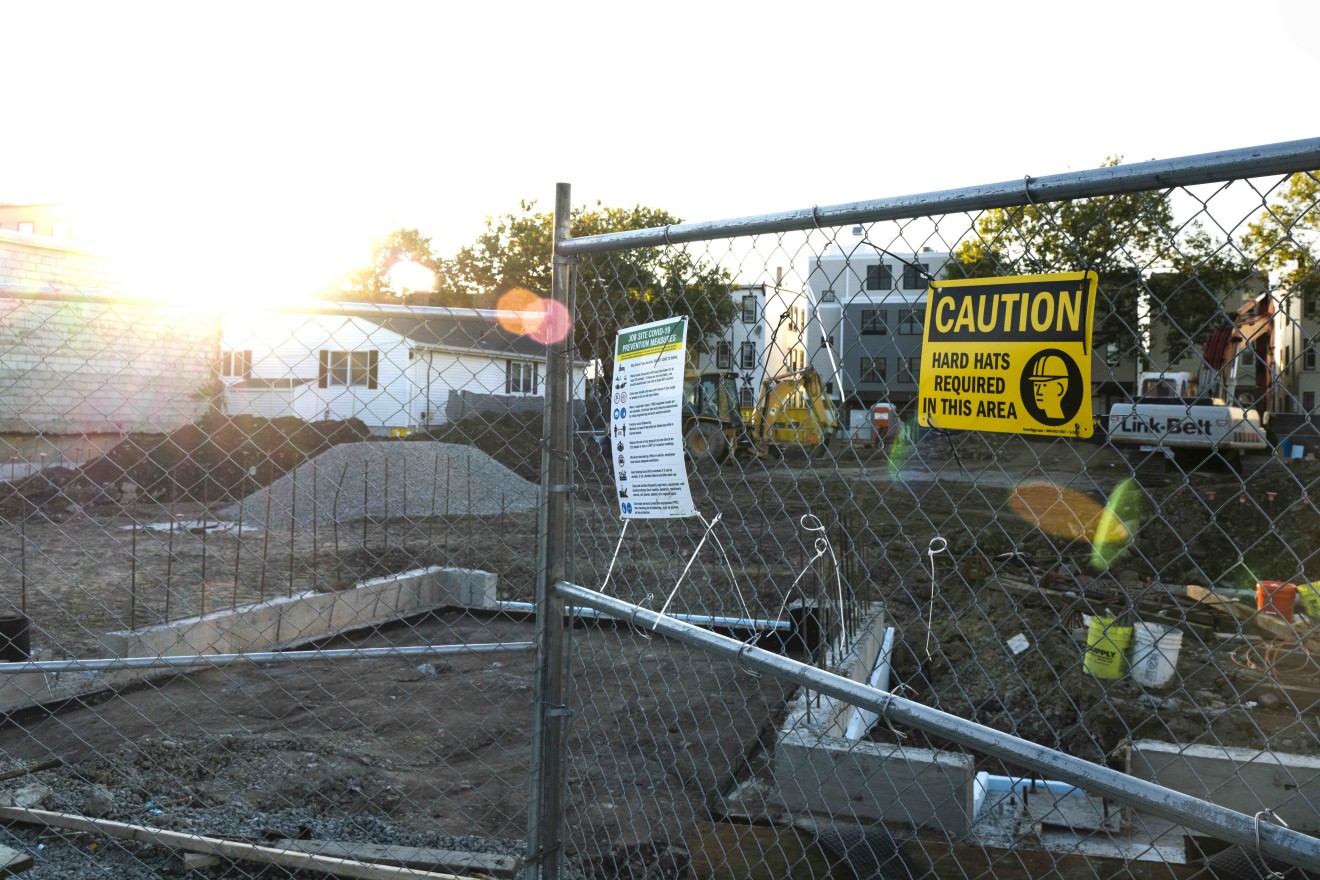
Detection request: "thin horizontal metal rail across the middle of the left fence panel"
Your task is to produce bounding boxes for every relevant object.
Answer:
[0,641,536,674]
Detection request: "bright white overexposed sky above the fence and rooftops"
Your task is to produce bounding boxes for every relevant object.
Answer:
[0,0,1320,303]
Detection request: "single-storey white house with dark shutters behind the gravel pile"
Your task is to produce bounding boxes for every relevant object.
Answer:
[220,306,583,434]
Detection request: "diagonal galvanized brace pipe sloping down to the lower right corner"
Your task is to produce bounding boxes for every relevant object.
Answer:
[556,582,1320,868]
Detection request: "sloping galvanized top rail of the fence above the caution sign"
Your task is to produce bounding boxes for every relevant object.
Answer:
[560,137,1320,255]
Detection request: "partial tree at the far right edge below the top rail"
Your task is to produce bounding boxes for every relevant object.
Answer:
[1242,172,1320,307]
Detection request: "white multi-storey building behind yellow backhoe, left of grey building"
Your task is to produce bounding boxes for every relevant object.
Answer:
[696,284,810,406]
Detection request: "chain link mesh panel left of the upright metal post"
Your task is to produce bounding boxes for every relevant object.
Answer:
[0,294,545,877]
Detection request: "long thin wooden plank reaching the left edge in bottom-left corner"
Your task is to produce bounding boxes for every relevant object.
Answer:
[0,806,475,880]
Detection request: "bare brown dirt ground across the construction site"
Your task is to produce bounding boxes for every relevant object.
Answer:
[0,422,1320,876]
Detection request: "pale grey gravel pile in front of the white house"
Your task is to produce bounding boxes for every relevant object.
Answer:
[218,441,539,529]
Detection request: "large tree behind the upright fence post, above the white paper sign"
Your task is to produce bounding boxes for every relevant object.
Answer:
[433,202,737,361]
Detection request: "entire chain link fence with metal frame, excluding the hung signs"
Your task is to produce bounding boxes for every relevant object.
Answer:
[0,141,1320,879]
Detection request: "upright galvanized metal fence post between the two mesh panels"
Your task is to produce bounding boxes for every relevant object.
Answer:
[523,183,573,880]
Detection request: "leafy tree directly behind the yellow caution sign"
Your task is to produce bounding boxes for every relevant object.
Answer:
[949,157,1254,354]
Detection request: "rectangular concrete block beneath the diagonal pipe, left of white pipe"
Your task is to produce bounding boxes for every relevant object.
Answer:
[771,731,975,839]
